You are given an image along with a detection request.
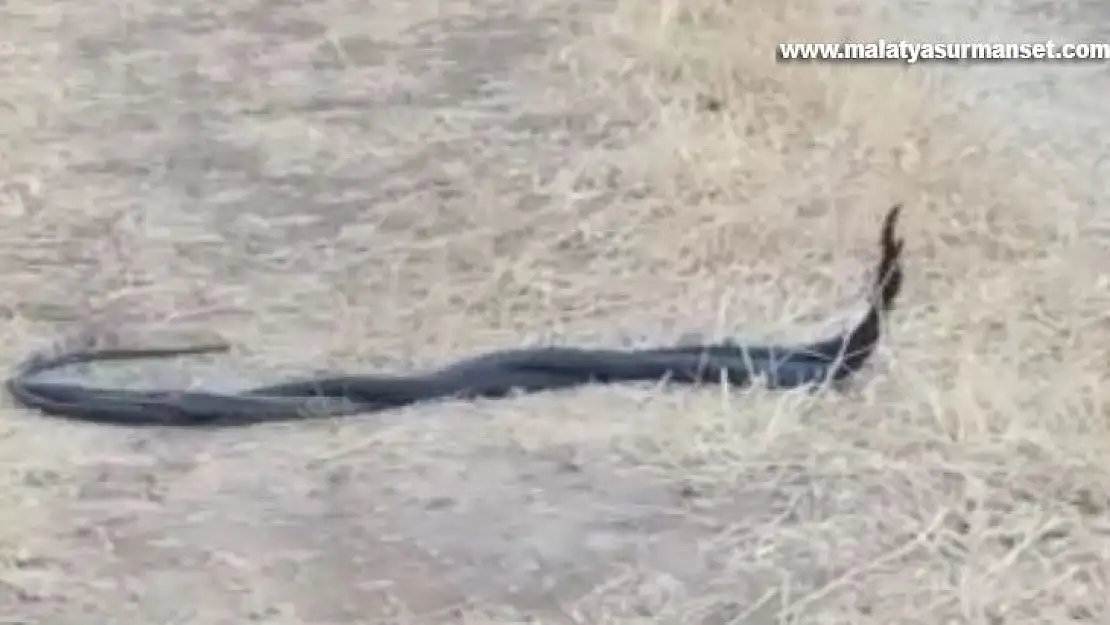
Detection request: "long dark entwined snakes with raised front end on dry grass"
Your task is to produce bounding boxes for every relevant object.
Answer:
[7,205,904,426]
